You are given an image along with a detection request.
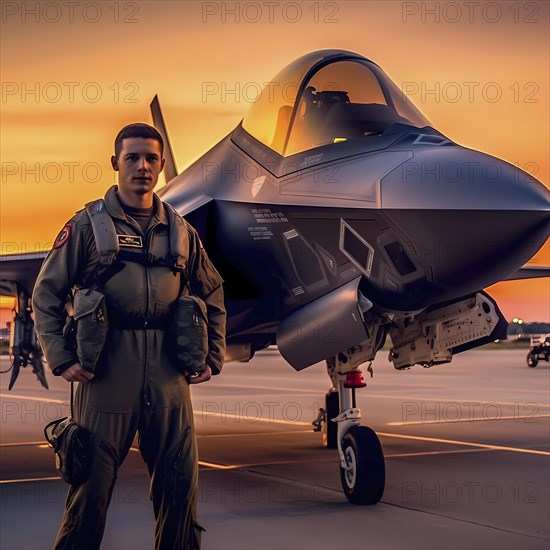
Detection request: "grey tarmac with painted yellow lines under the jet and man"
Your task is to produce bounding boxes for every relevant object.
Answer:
[0,349,550,550]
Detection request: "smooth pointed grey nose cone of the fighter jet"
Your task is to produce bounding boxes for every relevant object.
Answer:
[380,146,550,294]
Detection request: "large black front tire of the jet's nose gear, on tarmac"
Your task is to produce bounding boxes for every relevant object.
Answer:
[340,426,386,504]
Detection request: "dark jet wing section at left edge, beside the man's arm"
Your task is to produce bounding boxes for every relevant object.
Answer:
[0,252,48,296]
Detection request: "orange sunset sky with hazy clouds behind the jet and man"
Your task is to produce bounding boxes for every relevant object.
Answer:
[0,0,550,323]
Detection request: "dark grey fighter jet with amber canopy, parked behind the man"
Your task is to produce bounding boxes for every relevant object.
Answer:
[2,50,550,504]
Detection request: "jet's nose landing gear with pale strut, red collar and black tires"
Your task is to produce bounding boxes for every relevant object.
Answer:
[323,357,386,504]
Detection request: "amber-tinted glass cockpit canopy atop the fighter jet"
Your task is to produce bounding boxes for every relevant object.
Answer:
[242,50,430,157]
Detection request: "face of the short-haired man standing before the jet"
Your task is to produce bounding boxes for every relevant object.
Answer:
[111,138,164,195]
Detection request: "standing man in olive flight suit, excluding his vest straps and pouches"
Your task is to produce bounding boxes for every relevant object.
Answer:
[33,124,225,550]
